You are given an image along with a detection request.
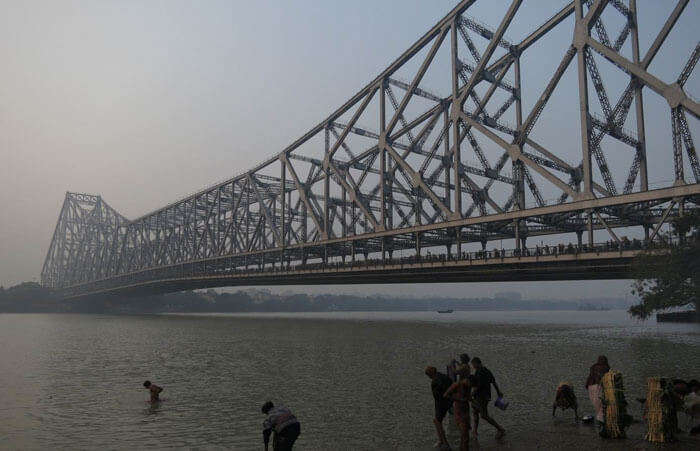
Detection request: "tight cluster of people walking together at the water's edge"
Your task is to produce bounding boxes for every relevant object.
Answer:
[425,354,506,450]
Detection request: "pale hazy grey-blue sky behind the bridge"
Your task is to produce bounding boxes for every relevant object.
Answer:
[0,0,700,297]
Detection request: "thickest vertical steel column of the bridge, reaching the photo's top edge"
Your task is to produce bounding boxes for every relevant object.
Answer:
[574,0,593,197]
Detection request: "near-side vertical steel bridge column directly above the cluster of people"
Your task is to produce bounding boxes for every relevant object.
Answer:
[452,16,462,217]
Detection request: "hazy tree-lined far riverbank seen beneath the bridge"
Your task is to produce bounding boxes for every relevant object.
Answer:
[0,283,629,317]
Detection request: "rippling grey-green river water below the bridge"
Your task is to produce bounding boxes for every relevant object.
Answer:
[0,311,700,449]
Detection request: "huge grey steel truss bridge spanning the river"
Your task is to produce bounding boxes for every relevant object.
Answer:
[41,0,700,298]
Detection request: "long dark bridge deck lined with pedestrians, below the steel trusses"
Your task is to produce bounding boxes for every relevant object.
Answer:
[67,250,641,298]
